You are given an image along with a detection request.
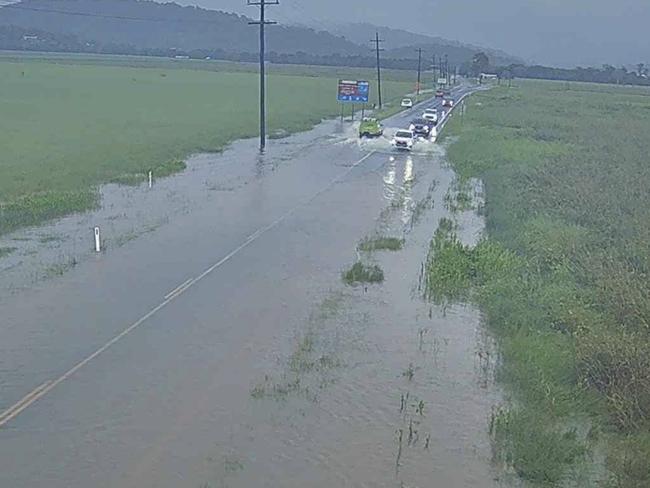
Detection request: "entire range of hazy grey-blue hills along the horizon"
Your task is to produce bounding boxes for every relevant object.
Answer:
[0,0,521,69]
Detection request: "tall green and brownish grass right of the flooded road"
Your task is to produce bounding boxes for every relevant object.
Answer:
[428,82,650,488]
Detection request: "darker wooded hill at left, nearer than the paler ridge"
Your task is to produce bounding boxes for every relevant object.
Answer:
[0,0,361,55]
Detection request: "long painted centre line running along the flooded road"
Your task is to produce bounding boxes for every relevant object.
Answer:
[0,151,375,427]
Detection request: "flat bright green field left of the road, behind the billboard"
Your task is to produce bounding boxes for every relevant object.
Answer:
[0,53,413,234]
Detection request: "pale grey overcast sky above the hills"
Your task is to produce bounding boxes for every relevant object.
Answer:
[176,0,650,66]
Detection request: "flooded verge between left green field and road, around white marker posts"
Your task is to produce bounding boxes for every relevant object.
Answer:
[0,122,344,301]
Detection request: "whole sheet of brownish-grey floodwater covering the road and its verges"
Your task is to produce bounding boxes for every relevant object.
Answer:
[0,86,506,488]
